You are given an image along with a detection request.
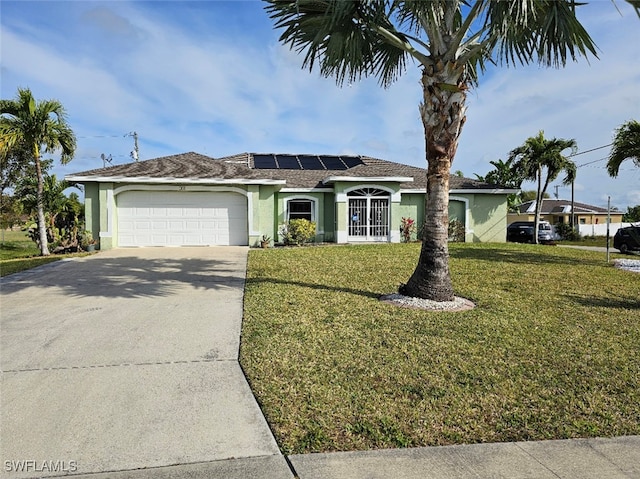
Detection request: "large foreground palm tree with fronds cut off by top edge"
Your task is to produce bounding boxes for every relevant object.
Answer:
[265,0,640,301]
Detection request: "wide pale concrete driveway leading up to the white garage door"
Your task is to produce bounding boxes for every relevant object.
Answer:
[0,247,288,477]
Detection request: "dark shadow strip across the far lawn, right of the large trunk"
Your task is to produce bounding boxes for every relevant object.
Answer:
[449,245,606,266]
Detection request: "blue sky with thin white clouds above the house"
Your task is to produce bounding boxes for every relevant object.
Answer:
[0,0,640,209]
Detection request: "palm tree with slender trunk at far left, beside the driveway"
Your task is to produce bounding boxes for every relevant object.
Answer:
[0,88,76,256]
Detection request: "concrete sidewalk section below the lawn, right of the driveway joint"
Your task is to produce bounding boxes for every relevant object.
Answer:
[289,436,640,479]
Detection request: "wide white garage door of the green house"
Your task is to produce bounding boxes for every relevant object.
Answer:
[116,191,249,246]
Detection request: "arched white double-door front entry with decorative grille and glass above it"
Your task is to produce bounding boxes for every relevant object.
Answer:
[348,188,389,241]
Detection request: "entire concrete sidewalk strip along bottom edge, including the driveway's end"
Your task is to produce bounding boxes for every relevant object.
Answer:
[41,436,640,479]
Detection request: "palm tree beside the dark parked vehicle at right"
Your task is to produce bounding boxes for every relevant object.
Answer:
[509,131,578,244]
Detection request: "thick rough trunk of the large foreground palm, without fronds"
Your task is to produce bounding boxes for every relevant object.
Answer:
[400,64,466,301]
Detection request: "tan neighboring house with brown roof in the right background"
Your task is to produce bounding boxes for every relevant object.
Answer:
[508,199,623,225]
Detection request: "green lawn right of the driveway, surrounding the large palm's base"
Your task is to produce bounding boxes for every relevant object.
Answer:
[241,244,640,453]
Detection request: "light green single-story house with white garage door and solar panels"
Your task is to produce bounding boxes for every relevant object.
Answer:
[66,153,515,249]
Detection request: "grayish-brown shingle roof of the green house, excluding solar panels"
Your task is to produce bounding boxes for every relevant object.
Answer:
[67,152,499,190]
